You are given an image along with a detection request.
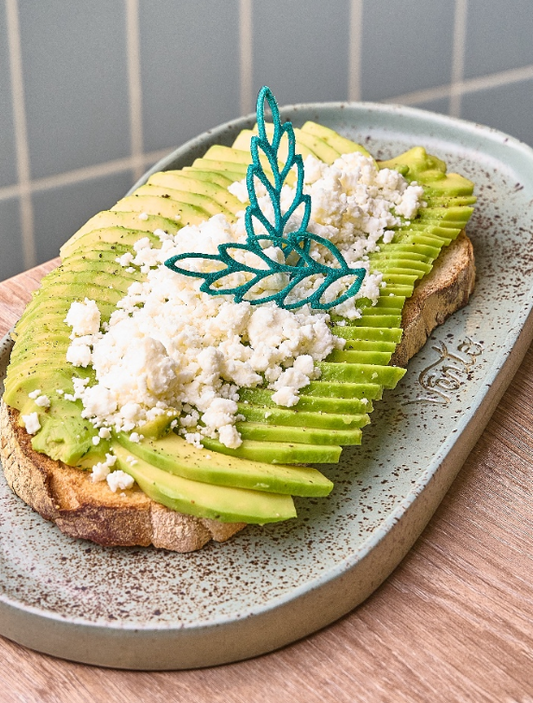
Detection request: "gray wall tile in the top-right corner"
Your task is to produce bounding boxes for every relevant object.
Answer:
[464,0,533,78]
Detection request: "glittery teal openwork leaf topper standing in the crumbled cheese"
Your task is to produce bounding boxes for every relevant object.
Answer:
[165,86,366,310]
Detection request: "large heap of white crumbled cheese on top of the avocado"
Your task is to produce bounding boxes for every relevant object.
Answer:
[65,147,423,448]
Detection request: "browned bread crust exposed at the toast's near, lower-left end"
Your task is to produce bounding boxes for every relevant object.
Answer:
[0,401,244,552]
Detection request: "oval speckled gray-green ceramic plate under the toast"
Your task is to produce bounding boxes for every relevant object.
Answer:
[0,104,533,669]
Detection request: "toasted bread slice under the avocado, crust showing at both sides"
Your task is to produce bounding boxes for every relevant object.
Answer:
[0,232,475,552]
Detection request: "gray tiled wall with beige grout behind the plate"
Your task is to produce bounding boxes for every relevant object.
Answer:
[0,0,533,279]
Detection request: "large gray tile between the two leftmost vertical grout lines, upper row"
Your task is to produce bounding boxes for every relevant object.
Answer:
[20,0,130,178]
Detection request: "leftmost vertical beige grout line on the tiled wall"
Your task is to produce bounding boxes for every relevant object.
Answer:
[6,0,37,268]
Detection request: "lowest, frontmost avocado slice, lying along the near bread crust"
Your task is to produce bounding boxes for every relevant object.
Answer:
[113,444,296,525]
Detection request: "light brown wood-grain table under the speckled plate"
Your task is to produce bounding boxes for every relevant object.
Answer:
[0,262,533,703]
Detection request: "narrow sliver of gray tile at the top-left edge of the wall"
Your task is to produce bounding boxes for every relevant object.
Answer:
[0,3,17,187]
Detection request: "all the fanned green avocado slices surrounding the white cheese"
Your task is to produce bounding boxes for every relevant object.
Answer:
[4,122,475,523]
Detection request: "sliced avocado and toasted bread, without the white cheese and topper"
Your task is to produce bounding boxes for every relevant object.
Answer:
[3,108,474,551]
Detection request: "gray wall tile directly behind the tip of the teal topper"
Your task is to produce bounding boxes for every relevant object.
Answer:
[253,0,349,105]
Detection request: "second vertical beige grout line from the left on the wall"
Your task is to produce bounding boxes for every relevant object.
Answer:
[125,0,143,181]
